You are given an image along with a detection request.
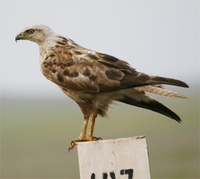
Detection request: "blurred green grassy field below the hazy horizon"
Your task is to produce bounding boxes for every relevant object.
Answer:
[1,89,199,178]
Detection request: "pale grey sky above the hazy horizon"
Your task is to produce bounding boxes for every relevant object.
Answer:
[0,0,200,98]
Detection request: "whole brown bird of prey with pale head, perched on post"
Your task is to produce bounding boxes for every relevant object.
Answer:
[15,23,189,149]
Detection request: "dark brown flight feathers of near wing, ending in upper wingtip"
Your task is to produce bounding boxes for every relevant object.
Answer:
[98,54,188,89]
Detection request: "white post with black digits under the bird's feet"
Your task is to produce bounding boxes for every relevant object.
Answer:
[78,136,151,179]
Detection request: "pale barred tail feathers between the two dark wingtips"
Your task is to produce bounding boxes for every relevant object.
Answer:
[134,85,188,98]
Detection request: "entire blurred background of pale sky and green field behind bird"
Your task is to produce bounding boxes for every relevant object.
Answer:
[0,0,200,178]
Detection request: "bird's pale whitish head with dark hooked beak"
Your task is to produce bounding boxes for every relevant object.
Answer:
[15,23,54,45]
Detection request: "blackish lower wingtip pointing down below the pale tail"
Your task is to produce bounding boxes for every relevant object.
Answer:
[118,94,181,123]
